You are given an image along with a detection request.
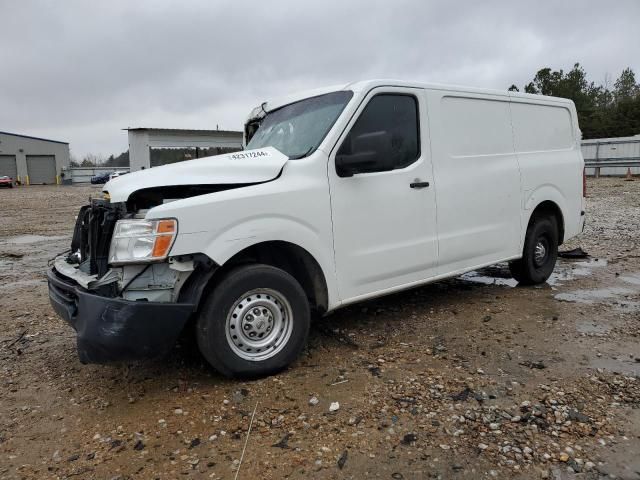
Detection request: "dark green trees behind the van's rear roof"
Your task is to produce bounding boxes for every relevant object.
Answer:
[509,63,640,139]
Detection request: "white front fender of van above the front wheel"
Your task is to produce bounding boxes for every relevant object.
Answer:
[147,156,340,309]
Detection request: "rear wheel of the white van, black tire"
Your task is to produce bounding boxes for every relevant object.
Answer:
[509,216,558,285]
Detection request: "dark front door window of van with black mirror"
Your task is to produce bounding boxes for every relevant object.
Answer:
[336,93,420,177]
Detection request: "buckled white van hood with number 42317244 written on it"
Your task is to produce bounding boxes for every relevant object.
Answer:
[103,147,289,202]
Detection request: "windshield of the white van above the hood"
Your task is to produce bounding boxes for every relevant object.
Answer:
[247,91,353,159]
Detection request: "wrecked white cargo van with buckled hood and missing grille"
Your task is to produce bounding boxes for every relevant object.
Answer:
[48,80,585,376]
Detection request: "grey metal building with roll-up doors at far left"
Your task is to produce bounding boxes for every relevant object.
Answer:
[0,132,69,185]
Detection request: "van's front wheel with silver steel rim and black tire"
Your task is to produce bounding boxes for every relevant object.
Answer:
[196,264,310,378]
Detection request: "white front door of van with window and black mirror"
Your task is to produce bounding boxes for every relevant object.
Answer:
[328,87,437,302]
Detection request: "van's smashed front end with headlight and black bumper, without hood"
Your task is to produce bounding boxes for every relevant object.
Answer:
[48,200,215,363]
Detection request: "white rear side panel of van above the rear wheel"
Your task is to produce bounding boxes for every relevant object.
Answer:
[511,97,584,242]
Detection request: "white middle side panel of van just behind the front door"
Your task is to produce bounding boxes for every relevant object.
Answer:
[427,90,522,275]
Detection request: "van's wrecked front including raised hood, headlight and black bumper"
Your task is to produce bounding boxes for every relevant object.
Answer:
[48,147,289,363]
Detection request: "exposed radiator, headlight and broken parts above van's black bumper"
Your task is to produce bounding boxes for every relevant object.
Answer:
[53,200,196,302]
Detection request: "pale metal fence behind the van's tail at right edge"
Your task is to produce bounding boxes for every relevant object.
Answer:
[582,135,640,176]
